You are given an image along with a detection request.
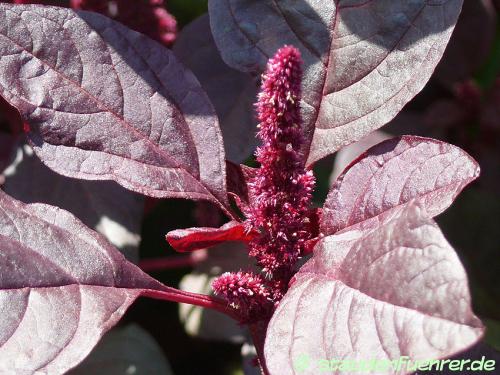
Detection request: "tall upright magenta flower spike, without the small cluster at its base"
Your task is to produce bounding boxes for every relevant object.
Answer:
[245,46,315,285]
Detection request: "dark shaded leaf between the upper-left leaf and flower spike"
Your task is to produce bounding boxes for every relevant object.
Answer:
[173,15,257,163]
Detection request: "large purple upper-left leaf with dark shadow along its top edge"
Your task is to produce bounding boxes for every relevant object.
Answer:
[0,4,227,209]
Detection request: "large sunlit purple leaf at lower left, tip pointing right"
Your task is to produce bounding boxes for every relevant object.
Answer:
[0,192,167,374]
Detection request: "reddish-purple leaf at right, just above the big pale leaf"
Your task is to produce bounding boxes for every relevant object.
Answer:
[320,136,479,235]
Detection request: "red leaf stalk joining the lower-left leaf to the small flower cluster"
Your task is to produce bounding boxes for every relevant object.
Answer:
[142,287,240,321]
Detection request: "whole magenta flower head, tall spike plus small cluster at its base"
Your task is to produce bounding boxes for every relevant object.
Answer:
[213,46,315,323]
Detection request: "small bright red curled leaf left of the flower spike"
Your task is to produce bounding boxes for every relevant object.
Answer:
[166,221,252,252]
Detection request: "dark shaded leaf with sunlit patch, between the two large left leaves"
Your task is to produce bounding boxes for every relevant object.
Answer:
[3,145,144,262]
